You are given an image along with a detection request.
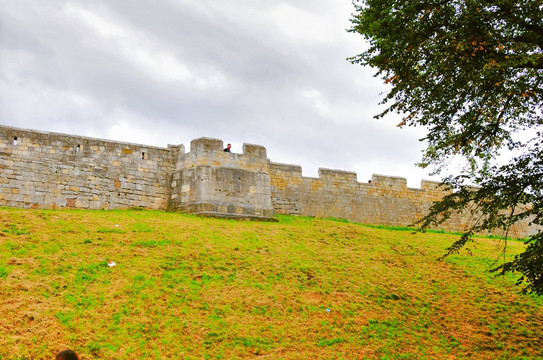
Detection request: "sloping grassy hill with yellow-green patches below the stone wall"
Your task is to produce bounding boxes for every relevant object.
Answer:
[0,208,543,359]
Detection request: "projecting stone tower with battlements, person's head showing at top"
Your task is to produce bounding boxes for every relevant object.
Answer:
[168,138,275,219]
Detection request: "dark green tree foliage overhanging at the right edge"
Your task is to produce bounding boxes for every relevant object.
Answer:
[350,0,543,294]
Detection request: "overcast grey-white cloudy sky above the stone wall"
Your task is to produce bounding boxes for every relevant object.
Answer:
[0,0,442,187]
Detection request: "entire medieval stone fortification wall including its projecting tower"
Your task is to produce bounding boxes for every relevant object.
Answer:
[0,125,533,237]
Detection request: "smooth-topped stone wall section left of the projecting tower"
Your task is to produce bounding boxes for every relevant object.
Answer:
[0,126,184,209]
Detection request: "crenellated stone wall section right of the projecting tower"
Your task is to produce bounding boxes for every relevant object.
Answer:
[270,163,467,229]
